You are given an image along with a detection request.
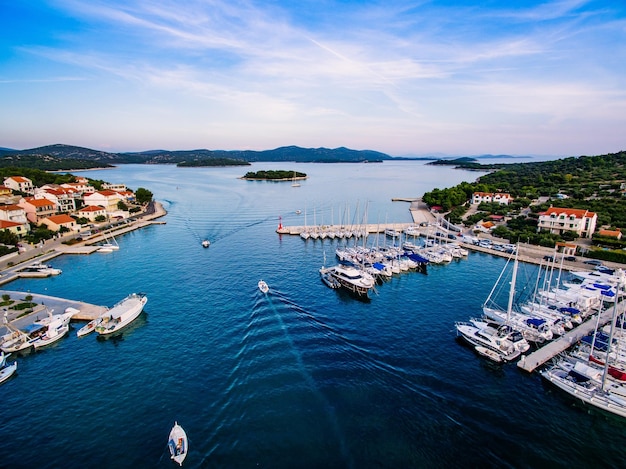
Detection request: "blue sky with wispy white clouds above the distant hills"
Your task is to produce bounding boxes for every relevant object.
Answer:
[0,0,626,156]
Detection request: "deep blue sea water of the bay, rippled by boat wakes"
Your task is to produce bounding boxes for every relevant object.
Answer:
[0,161,626,469]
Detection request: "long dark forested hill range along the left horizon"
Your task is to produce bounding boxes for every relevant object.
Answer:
[0,144,392,165]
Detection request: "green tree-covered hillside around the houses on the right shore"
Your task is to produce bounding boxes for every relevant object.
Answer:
[423,151,626,256]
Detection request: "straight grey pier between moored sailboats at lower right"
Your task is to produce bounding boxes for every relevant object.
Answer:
[517,300,626,373]
